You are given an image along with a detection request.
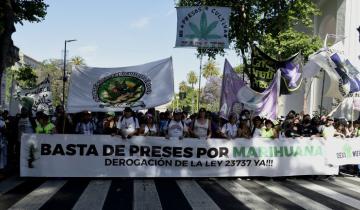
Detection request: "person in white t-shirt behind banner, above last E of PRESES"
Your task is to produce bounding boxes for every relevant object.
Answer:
[165,109,188,139]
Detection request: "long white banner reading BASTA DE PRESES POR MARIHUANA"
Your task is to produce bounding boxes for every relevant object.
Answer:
[21,134,338,177]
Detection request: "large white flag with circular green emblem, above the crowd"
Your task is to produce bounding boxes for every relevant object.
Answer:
[67,57,174,113]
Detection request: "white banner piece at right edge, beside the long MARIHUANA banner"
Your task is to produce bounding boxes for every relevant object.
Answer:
[326,138,360,165]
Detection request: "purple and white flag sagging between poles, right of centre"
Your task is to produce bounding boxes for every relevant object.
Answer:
[220,60,281,120]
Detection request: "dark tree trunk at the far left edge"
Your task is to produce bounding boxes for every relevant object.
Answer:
[0,0,15,106]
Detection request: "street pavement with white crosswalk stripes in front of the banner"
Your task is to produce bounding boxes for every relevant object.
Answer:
[0,176,360,210]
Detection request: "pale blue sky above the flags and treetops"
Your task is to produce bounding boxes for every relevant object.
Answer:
[12,0,241,92]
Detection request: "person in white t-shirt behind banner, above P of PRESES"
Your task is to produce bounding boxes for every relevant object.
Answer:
[117,107,140,139]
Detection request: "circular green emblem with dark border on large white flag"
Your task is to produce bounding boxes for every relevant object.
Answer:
[97,76,145,104]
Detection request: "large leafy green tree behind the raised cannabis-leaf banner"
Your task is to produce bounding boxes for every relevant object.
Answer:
[178,0,321,67]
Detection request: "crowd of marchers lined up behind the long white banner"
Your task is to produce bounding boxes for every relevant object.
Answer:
[0,106,360,177]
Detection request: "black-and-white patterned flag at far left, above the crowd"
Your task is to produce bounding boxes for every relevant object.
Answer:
[16,77,53,114]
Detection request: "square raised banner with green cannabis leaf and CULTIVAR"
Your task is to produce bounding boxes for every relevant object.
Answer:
[175,6,231,48]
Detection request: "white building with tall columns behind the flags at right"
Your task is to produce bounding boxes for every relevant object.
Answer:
[279,0,360,119]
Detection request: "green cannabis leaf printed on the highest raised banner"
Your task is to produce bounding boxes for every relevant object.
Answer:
[185,12,221,40]
